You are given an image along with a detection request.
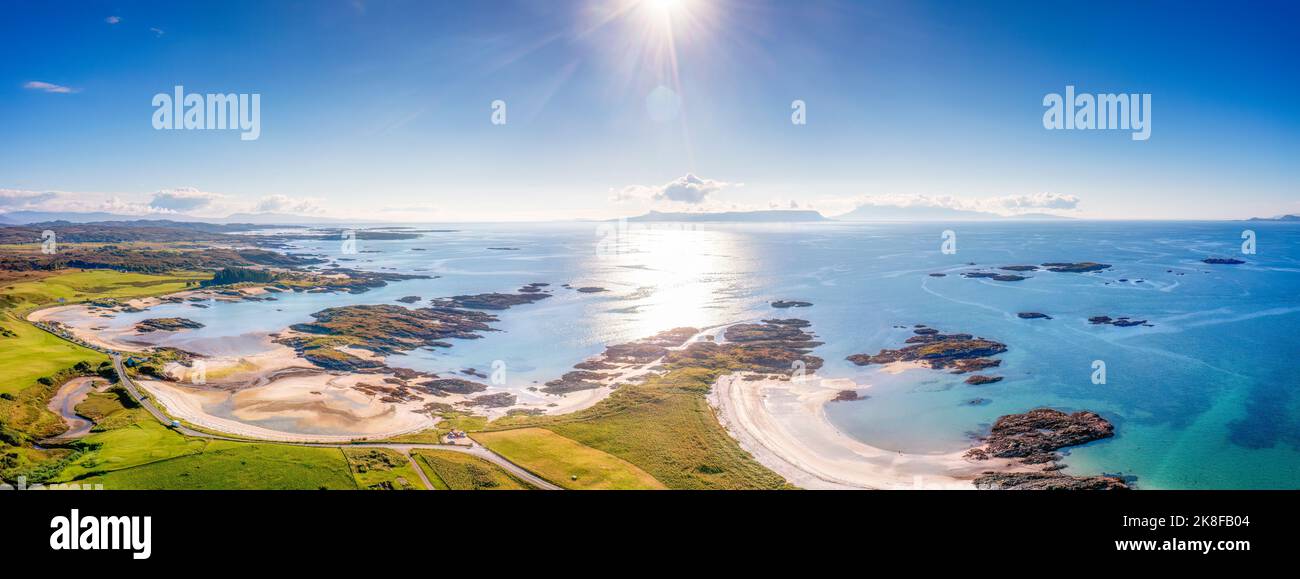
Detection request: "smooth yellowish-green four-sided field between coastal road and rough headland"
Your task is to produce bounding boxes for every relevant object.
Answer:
[471,428,667,489]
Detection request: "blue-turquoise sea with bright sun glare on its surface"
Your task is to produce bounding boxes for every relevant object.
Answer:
[73,221,1300,489]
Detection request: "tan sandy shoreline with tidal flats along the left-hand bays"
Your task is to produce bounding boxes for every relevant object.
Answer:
[26,288,639,442]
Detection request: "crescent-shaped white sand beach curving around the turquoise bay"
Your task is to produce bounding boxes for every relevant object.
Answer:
[709,368,1030,491]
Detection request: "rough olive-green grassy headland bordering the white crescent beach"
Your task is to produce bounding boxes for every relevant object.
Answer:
[488,368,790,489]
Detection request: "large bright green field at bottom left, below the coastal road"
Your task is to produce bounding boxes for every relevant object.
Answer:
[78,440,356,491]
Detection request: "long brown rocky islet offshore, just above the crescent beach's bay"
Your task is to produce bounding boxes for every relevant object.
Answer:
[848,328,1006,373]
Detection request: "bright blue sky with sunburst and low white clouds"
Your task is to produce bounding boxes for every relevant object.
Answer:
[0,0,1300,220]
